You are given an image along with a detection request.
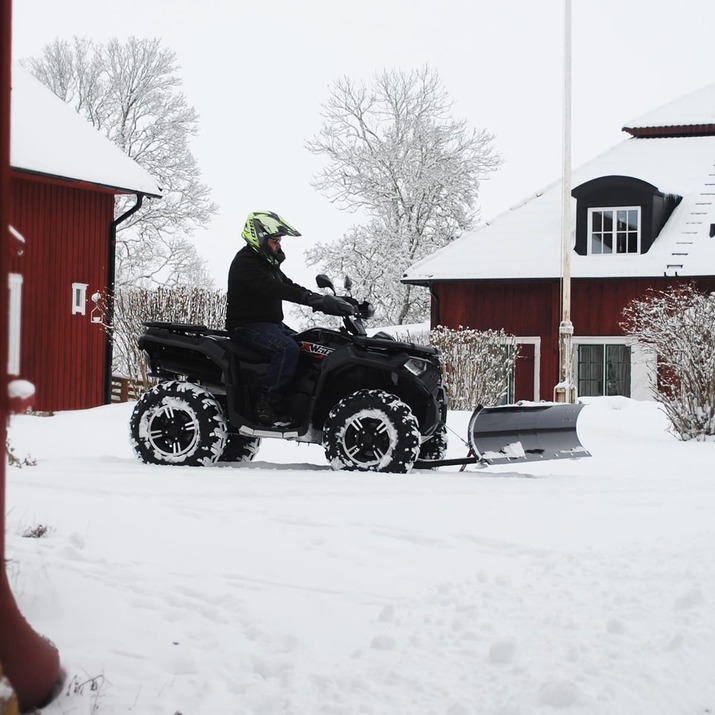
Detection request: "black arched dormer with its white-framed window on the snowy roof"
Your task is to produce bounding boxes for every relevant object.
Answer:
[571,176,681,256]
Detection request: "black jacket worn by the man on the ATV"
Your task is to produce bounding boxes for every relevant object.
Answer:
[226,246,310,330]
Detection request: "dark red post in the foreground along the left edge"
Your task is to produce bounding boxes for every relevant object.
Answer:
[0,0,60,710]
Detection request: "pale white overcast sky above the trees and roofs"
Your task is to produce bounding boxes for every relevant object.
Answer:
[13,0,715,287]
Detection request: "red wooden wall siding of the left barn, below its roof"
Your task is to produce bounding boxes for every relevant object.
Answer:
[11,174,114,411]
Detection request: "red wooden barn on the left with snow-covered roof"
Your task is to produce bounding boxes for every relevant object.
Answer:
[8,66,161,411]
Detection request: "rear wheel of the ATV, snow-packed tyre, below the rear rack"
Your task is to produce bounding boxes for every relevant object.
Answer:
[129,380,227,466]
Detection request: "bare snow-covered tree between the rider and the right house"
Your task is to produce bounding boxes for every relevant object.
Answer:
[306,66,501,325]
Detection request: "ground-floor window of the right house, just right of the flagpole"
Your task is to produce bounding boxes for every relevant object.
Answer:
[577,343,631,397]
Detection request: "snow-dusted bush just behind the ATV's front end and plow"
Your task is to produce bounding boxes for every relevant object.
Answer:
[430,325,517,410]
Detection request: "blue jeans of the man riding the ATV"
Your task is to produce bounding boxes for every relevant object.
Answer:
[229,323,300,405]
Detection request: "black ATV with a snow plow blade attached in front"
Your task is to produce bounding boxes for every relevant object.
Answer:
[130,275,588,473]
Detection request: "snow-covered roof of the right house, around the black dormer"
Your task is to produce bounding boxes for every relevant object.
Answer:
[403,84,715,284]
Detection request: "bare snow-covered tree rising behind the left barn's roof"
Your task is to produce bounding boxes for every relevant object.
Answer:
[23,37,217,287]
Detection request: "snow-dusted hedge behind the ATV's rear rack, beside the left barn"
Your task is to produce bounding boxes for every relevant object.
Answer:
[112,288,226,384]
